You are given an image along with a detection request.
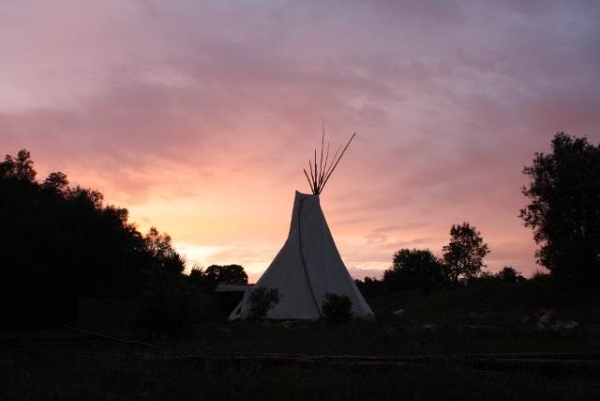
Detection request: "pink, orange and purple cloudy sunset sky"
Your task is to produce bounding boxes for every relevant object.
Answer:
[0,0,600,281]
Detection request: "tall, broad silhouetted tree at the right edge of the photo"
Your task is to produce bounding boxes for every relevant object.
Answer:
[519,132,600,278]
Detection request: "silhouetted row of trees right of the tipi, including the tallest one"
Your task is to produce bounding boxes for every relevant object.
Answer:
[357,132,600,296]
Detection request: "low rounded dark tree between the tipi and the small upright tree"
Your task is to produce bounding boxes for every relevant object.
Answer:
[383,249,444,292]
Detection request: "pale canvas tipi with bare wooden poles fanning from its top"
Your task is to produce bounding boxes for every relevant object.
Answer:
[229,134,373,320]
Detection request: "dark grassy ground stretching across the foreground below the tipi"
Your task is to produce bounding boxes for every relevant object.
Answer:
[0,284,600,400]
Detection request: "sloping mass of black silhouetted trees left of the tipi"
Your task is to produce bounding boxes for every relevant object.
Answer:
[0,150,185,325]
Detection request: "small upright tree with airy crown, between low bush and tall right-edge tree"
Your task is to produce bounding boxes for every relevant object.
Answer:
[443,222,490,284]
